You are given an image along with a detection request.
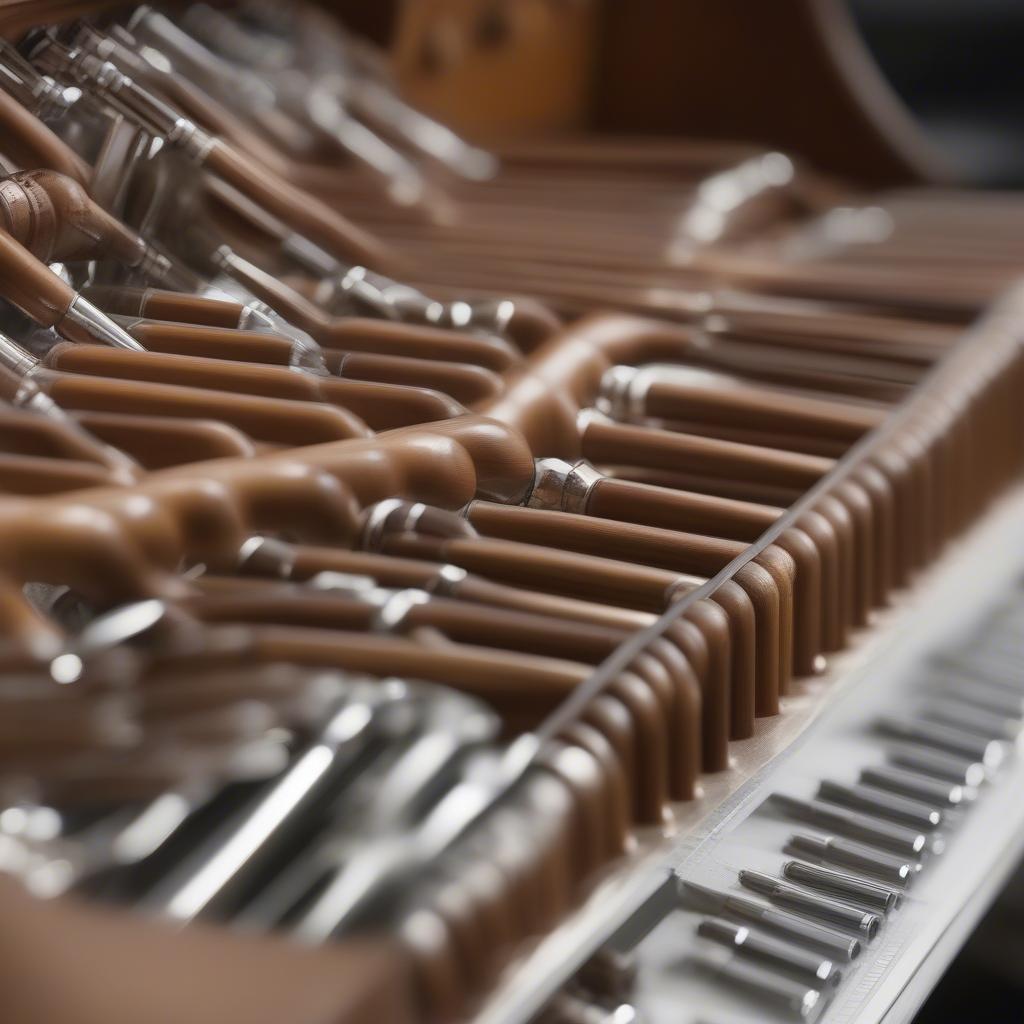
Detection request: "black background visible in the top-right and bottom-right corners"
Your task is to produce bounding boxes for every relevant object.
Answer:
[848,0,1024,1024]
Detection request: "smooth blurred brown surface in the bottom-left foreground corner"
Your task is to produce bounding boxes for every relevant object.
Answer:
[0,881,418,1024]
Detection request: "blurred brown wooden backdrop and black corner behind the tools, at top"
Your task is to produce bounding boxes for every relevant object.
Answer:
[339,0,1024,187]
